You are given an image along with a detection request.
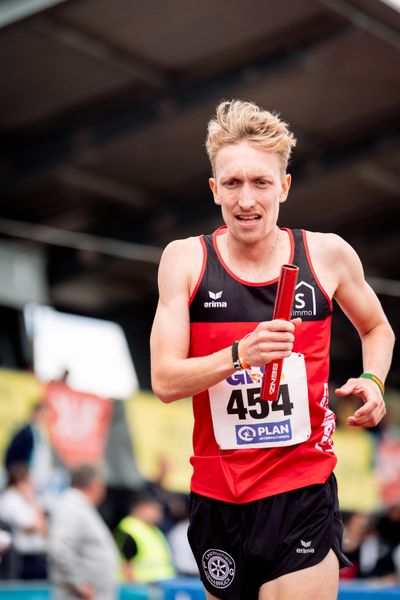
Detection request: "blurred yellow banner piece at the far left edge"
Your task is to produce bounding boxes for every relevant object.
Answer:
[0,369,43,462]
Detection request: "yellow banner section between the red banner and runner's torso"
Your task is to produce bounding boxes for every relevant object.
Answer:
[125,392,193,492]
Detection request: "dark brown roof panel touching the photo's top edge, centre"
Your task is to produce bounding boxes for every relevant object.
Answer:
[54,0,337,69]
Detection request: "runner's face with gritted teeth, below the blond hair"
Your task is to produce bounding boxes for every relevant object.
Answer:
[210,141,291,243]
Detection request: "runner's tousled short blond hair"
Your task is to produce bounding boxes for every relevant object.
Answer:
[206,100,296,175]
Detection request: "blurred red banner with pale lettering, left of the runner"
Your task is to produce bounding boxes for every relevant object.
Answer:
[44,382,113,467]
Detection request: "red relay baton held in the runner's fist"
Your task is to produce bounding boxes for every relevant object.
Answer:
[260,265,299,402]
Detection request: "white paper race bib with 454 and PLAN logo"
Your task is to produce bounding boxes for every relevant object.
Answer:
[209,353,311,450]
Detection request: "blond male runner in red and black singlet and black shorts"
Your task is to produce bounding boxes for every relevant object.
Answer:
[151,101,394,600]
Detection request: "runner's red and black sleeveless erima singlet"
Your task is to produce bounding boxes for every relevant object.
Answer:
[190,227,336,503]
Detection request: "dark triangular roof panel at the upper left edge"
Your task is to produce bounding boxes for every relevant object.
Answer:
[0,24,134,129]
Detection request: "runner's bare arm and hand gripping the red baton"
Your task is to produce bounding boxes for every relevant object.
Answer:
[150,238,295,402]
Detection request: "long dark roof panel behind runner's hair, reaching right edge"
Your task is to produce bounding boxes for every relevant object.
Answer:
[69,25,400,189]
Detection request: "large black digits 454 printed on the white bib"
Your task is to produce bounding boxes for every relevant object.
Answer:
[226,383,294,420]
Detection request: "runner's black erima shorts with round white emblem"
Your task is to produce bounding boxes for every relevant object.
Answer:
[188,474,351,600]
